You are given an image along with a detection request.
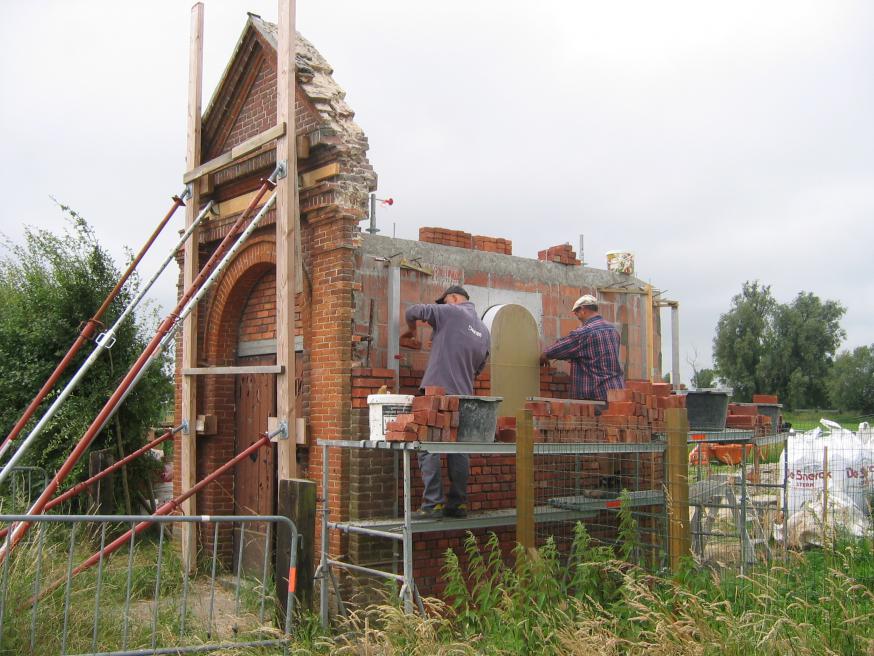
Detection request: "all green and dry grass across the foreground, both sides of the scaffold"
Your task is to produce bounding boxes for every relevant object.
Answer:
[0,512,874,656]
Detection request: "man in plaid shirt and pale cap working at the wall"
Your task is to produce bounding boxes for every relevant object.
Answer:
[540,294,625,401]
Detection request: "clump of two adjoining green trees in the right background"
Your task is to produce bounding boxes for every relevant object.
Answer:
[713,281,846,408]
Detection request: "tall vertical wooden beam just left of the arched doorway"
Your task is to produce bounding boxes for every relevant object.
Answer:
[179,2,203,570]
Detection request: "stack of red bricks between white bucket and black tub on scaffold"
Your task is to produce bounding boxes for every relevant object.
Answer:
[385,387,460,442]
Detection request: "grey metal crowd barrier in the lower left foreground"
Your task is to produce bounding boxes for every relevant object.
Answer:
[0,515,299,656]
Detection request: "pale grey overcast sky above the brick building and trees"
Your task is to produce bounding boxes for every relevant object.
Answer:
[0,0,874,382]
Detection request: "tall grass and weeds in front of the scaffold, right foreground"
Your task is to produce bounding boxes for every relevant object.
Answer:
[307,525,874,656]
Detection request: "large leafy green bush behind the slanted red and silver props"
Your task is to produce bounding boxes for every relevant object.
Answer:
[0,206,173,508]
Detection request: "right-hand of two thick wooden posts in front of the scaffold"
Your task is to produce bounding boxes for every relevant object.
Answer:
[665,408,692,572]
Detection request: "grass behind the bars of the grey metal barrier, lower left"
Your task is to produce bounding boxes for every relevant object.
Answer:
[0,527,281,656]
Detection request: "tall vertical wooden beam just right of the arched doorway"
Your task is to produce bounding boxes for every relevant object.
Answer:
[276,0,300,481]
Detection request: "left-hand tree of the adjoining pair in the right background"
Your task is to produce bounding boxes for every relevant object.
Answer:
[713,281,777,401]
